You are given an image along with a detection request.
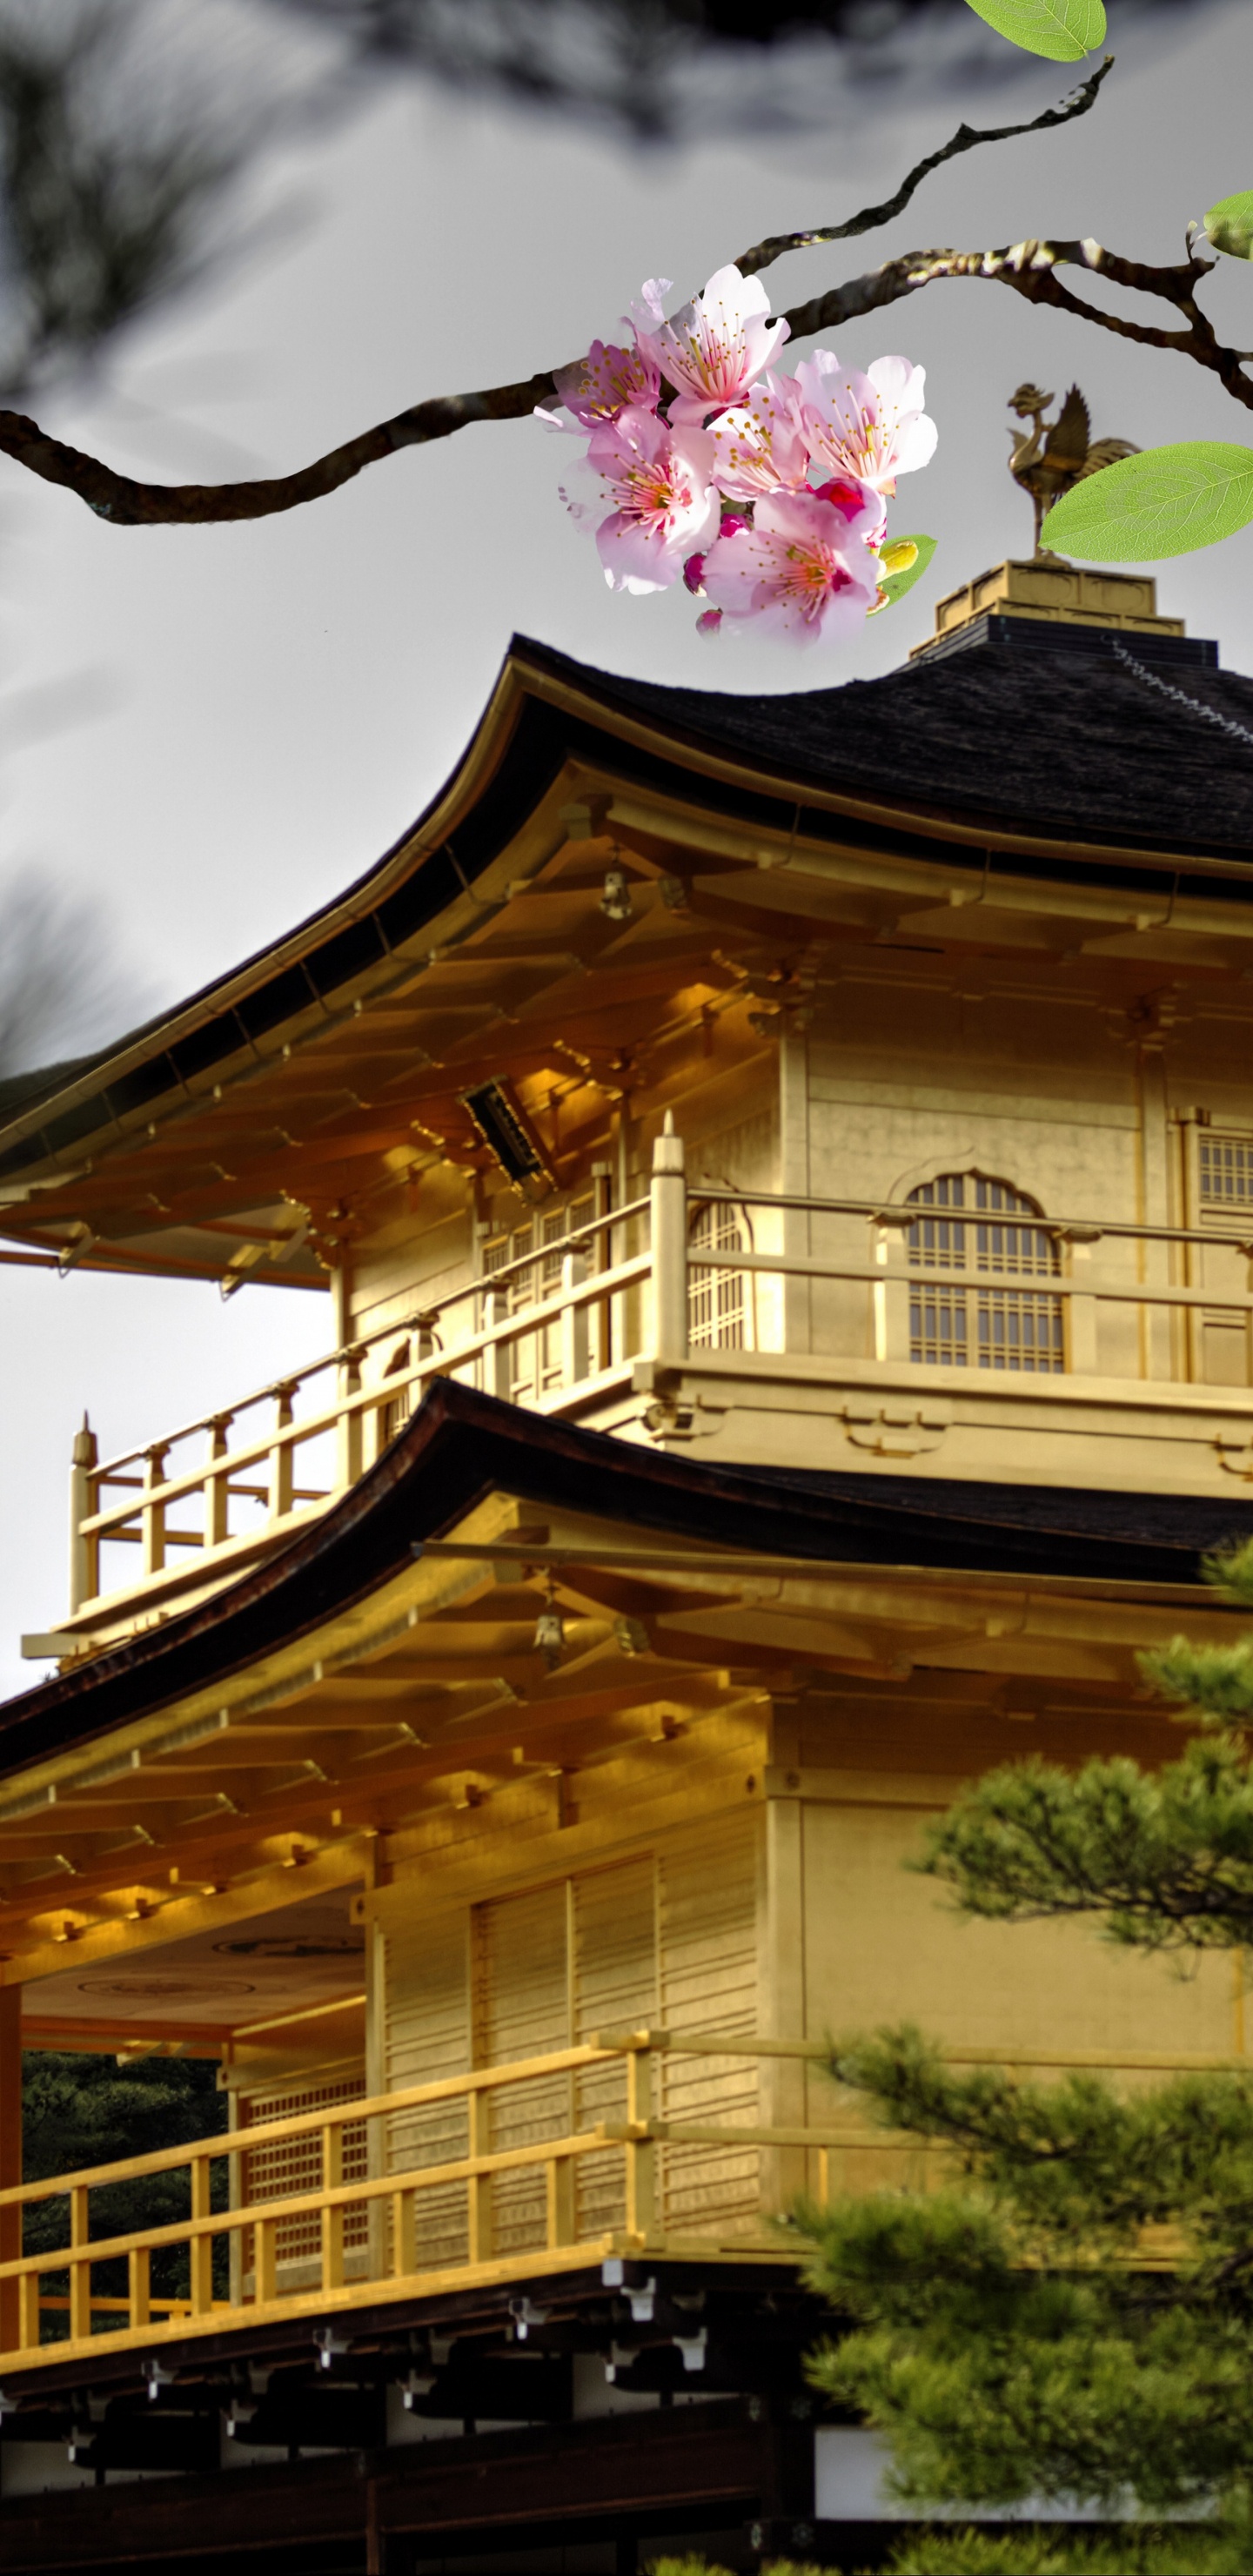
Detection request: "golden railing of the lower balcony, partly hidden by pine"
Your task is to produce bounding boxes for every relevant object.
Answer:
[0,2029,1232,2380]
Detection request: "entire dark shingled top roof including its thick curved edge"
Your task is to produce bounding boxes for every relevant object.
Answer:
[0,618,1253,1172]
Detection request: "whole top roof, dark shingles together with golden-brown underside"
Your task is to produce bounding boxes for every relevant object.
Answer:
[0,641,1253,1285]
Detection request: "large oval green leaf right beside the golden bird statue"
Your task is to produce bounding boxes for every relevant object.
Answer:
[1044,438,1253,564]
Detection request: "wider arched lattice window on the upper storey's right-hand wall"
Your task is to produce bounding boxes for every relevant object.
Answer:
[908,1172,1065,1376]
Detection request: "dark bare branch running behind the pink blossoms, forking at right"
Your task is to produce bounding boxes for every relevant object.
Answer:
[0,64,1253,528]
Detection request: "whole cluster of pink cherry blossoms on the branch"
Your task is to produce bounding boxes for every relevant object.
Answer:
[539,268,936,644]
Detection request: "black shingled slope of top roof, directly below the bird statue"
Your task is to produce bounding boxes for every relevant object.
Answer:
[519,618,1253,855]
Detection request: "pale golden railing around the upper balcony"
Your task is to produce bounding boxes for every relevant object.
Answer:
[50,1130,1253,1631]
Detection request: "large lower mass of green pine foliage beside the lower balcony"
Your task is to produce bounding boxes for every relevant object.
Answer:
[797,2029,1253,2512]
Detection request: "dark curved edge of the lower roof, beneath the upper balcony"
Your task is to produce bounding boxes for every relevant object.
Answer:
[0,1379,1237,1777]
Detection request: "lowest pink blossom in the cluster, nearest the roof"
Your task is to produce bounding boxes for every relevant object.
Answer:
[704,492,879,644]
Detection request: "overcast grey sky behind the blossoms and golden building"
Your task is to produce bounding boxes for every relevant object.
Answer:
[0,0,1253,1690]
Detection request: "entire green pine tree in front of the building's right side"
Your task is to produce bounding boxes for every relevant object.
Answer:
[797,1543,1253,2576]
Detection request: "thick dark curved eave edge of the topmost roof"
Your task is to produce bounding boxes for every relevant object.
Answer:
[0,623,1253,1208]
